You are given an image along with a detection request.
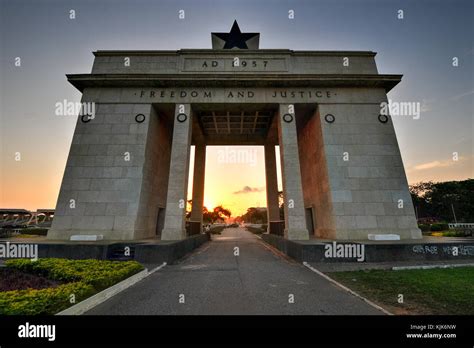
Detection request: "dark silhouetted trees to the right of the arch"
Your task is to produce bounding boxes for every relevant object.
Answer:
[410,179,474,222]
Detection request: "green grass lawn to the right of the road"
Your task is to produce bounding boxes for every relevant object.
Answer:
[328,267,474,315]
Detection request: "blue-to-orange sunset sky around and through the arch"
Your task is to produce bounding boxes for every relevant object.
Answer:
[0,0,474,215]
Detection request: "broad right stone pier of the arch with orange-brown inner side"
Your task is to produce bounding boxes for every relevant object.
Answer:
[299,99,420,240]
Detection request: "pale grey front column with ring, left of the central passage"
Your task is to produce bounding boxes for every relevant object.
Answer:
[161,104,192,240]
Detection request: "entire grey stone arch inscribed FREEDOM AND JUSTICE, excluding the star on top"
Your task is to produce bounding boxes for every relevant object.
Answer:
[48,50,421,240]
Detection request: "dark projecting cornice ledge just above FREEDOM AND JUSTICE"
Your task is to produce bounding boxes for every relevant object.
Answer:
[66,73,402,92]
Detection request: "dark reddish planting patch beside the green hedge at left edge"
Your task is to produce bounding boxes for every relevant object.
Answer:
[0,267,62,291]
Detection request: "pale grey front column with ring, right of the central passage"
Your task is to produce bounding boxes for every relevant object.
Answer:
[278,104,309,240]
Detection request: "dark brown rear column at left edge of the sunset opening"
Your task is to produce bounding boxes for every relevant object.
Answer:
[190,144,206,234]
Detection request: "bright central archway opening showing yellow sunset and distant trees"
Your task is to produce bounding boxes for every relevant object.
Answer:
[186,145,283,234]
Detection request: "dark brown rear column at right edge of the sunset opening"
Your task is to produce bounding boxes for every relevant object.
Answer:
[265,144,281,234]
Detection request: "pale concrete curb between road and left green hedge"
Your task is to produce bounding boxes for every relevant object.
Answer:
[55,262,166,315]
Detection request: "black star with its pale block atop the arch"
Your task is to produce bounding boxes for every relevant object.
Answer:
[211,21,260,49]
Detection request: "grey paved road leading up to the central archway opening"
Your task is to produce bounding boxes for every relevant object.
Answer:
[87,228,383,315]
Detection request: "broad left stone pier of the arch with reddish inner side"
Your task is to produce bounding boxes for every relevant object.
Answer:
[48,103,170,239]
